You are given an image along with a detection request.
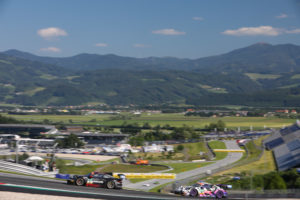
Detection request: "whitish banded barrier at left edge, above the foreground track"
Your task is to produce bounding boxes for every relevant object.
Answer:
[0,160,57,177]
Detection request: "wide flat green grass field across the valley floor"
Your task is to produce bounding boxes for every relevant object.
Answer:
[4,113,295,129]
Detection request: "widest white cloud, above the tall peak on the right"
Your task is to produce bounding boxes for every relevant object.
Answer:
[222,26,300,36]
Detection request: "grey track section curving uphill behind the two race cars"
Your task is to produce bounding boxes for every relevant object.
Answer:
[126,140,243,191]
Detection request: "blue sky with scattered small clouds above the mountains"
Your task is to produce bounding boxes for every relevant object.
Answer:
[0,0,300,58]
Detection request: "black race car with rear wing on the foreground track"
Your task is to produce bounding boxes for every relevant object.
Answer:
[67,173,124,189]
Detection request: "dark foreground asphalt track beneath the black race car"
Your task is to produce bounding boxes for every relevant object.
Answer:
[0,173,204,200]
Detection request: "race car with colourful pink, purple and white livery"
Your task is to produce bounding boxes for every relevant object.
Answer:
[174,182,227,199]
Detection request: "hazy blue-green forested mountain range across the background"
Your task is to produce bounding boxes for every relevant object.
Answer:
[0,43,300,106]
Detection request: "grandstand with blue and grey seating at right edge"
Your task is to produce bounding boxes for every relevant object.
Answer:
[264,121,300,171]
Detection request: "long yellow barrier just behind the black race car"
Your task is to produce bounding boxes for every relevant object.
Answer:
[113,172,176,179]
